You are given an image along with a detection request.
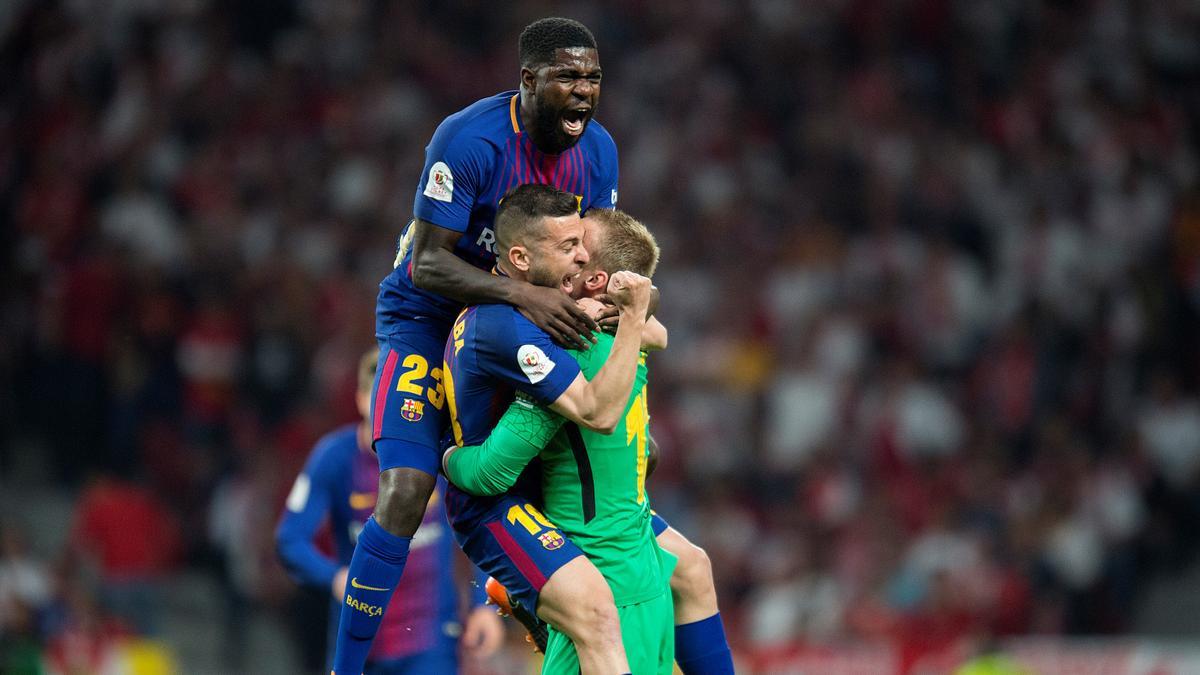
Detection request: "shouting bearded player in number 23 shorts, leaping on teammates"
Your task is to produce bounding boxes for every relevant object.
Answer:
[334,18,617,674]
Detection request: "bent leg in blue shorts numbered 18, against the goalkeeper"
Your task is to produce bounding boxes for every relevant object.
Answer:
[446,485,629,675]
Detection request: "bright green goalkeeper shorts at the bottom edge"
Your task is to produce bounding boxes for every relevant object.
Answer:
[541,589,674,675]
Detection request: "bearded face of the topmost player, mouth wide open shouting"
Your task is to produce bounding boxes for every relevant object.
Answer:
[529,47,601,155]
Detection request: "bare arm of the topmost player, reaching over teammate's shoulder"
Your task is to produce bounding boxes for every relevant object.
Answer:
[413,219,596,350]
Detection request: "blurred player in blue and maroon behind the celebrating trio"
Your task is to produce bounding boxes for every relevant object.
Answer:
[275,350,504,675]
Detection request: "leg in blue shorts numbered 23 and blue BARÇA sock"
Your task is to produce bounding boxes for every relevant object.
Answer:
[334,328,445,675]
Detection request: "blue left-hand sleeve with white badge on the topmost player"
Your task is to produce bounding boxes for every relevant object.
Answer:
[413,123,493,232]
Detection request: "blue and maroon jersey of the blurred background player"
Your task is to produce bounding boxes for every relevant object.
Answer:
[276,424,458,662]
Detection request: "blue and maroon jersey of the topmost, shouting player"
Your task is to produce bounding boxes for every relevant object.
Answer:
[377,91,618,335]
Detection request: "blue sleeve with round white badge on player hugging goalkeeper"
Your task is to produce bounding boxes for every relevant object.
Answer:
[479,306,580,405]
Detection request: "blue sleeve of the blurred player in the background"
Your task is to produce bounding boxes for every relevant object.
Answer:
[275,444,338,589]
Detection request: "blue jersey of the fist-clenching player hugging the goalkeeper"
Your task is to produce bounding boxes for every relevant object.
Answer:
[443,300,580,446]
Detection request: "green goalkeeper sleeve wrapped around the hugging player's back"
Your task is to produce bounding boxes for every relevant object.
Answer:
[446,394,566,496]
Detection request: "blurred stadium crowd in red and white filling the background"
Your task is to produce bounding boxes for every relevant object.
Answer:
[0,0,1200,669]
